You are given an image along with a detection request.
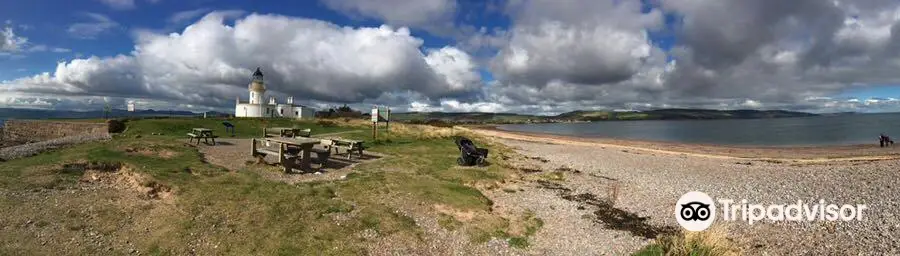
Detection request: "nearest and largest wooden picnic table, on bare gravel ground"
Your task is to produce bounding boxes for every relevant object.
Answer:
[250,137,330,172]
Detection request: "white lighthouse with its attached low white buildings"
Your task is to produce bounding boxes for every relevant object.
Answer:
[234,68,316,119]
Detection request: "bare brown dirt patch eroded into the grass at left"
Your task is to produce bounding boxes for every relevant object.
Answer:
[70,163,173,200]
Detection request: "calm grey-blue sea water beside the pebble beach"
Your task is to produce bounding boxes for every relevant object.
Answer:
[499,113,900,146]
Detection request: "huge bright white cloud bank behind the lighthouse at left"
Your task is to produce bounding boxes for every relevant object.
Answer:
[0,12,481,110]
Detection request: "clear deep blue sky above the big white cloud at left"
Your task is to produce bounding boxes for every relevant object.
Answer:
[0,0,458,80]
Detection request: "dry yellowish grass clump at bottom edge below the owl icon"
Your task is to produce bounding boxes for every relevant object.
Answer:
[633,226,740,256]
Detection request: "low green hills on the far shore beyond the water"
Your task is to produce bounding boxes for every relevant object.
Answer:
[391,109,817,123]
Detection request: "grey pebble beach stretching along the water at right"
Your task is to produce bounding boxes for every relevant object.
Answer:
[491,136,900,255]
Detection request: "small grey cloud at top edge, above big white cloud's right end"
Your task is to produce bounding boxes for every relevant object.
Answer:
[321,0,457,35]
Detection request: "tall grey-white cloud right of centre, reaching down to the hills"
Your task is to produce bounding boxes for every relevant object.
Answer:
[482,0,670,113]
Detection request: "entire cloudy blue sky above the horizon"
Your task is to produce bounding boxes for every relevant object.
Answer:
[0,0,900,113]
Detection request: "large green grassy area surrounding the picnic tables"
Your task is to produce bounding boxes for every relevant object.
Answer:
[0,118,540,255]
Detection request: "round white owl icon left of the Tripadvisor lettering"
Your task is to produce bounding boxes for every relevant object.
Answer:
[675,191,716,231]
